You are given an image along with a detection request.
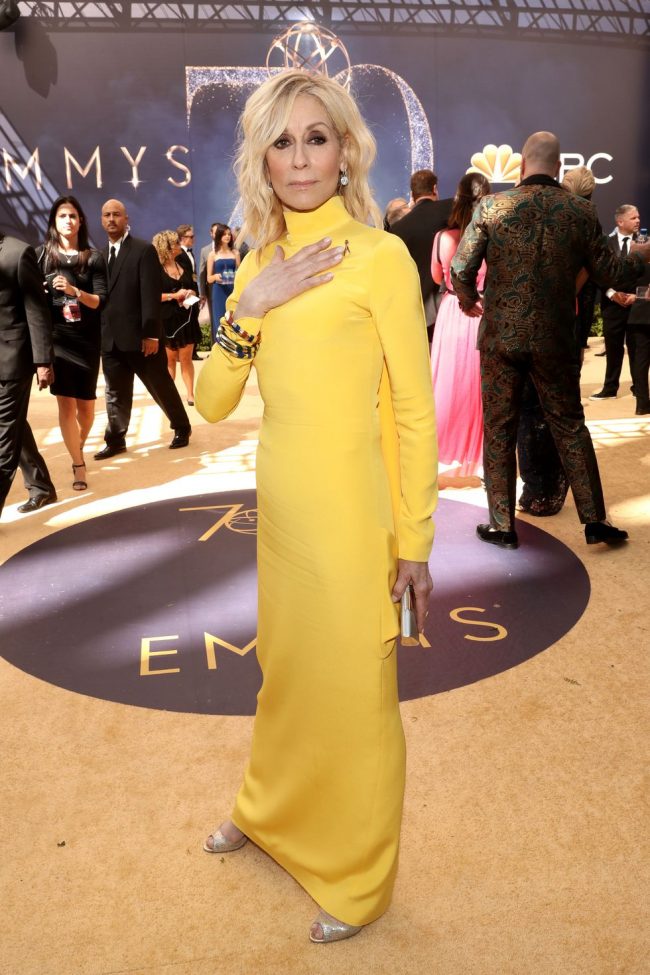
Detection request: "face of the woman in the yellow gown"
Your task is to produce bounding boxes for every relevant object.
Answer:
[265,95,345,211]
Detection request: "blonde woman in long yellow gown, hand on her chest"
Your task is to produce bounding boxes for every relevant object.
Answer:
[196,71,437,942]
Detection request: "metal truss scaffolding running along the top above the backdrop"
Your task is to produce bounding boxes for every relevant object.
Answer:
[20,0,650,43]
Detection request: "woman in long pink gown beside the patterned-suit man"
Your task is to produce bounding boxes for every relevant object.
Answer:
[431,173,490,477]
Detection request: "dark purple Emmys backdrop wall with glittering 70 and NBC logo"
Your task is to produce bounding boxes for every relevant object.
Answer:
[0,7,650,244]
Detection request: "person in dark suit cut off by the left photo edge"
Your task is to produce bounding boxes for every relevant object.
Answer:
[0,234,54,512]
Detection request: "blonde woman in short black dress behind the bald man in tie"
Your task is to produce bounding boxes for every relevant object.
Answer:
[152,230,196,406]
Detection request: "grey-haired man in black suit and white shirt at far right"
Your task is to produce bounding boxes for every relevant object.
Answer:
[589,203,647,400]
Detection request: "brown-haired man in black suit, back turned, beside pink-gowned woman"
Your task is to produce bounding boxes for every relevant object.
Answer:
[389,169,454,338]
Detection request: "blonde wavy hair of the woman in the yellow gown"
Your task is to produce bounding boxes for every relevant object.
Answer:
[235,70,381,251]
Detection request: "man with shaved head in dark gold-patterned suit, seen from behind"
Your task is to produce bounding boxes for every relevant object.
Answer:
[451,132,650,548]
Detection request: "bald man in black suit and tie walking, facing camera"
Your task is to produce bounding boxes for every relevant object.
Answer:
[95,200,192,460]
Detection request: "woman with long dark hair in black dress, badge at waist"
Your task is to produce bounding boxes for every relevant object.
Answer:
[39,196,107,491]
